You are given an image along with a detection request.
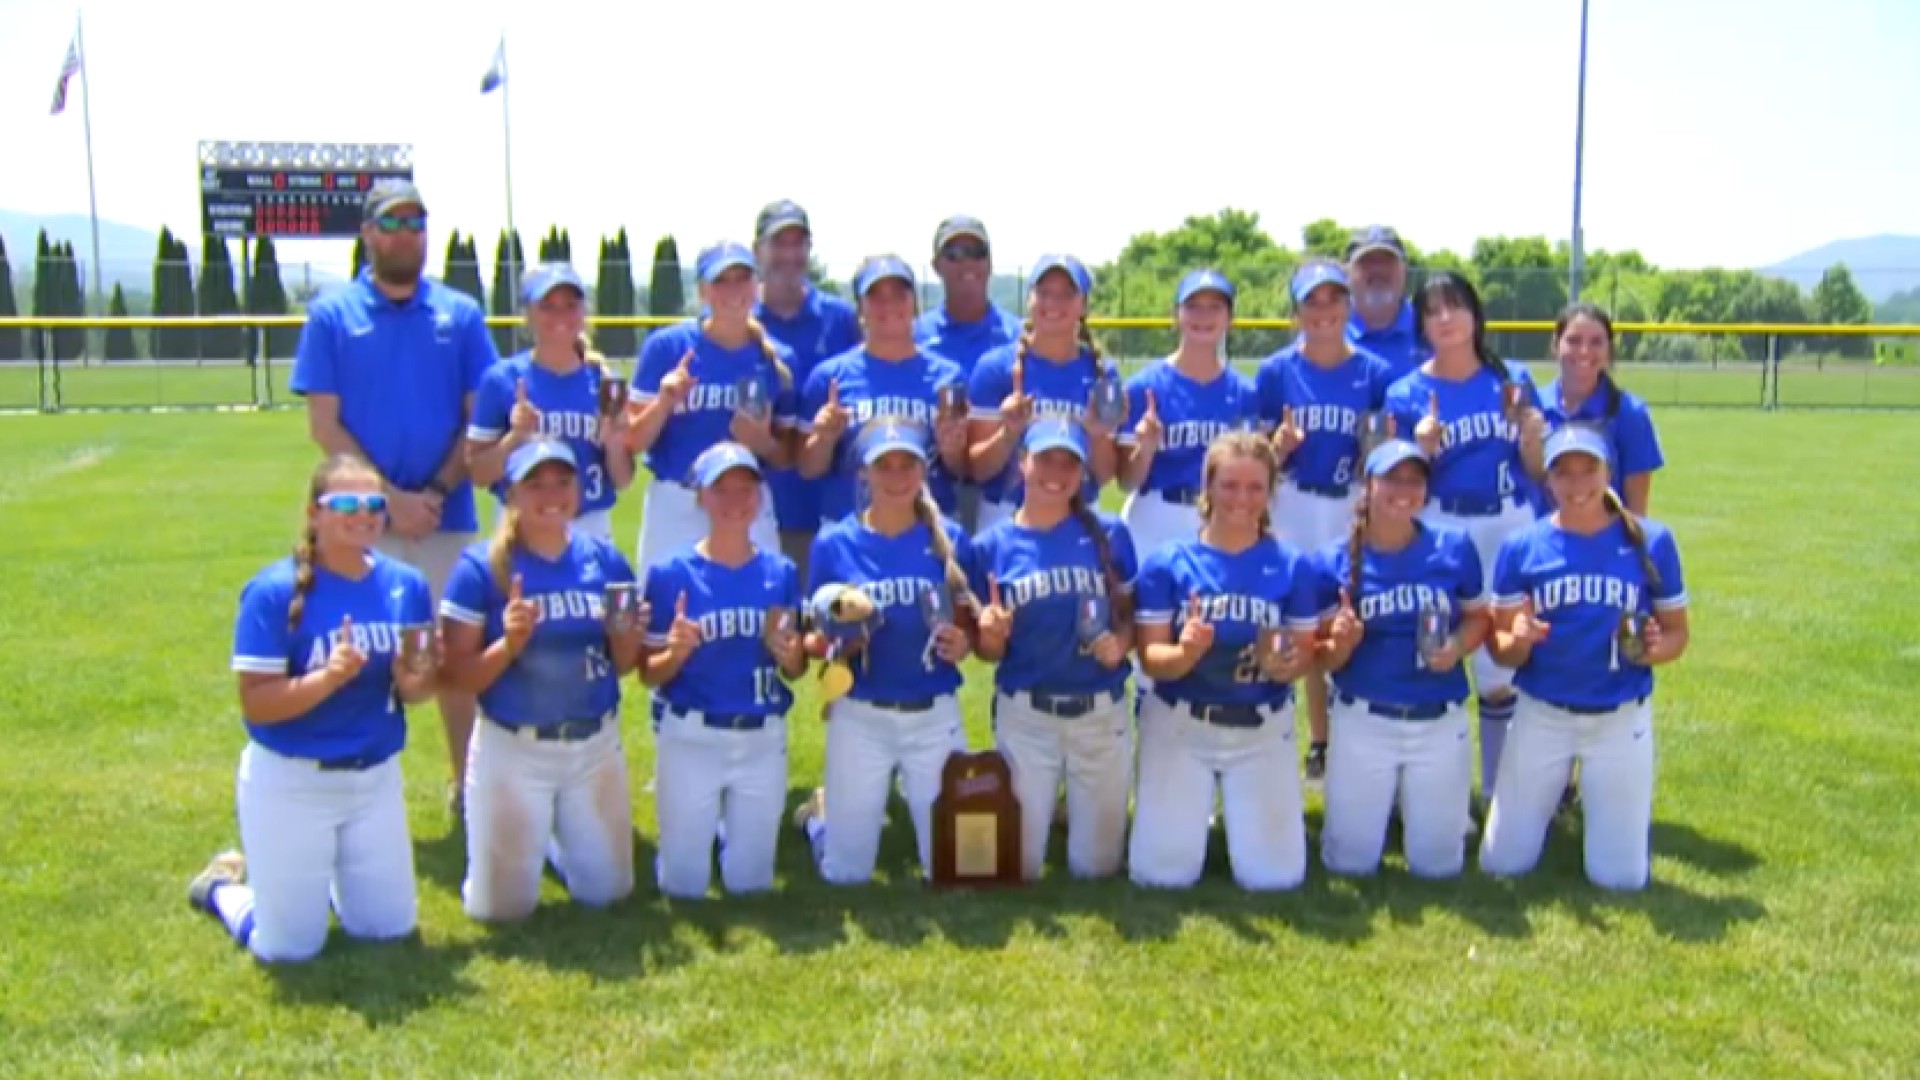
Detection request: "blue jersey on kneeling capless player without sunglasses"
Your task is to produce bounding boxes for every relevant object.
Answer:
[1135,536,1321,705]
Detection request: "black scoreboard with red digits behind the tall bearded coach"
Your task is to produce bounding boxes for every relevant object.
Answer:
[200,142,413,238]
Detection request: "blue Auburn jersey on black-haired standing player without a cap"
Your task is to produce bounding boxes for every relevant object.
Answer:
[1386,363,1540,507]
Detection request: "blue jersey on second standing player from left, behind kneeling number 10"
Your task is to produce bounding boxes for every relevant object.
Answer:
[634,321,797,486]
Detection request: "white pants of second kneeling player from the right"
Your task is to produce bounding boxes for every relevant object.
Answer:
[1321,698,1466,878]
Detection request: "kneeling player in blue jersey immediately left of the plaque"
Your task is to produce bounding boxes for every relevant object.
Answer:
[795,417,979,884]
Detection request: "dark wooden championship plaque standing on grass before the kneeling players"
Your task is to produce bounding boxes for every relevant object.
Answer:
[933,749,1021,888]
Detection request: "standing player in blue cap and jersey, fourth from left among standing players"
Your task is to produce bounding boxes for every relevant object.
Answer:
[968,256,1119,532]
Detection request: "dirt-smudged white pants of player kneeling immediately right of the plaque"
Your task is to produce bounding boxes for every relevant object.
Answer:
[993,694,1133,880]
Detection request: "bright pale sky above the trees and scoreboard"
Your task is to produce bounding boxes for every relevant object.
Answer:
[0,0,1920,271]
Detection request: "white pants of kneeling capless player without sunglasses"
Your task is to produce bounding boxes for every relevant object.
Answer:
[1127,694,1308,890]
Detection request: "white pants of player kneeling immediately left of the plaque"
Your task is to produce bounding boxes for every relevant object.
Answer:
[814,694,962,884]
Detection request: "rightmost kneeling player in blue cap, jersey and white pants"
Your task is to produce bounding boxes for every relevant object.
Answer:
[1480,427,1690,890]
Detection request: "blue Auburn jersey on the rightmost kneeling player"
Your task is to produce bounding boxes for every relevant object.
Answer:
[1494,519,1686,709]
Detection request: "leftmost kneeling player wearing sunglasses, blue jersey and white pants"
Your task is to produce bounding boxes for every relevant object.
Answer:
[188,454,436,961]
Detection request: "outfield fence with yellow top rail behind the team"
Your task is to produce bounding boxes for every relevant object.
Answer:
[0,315,1920,413]
